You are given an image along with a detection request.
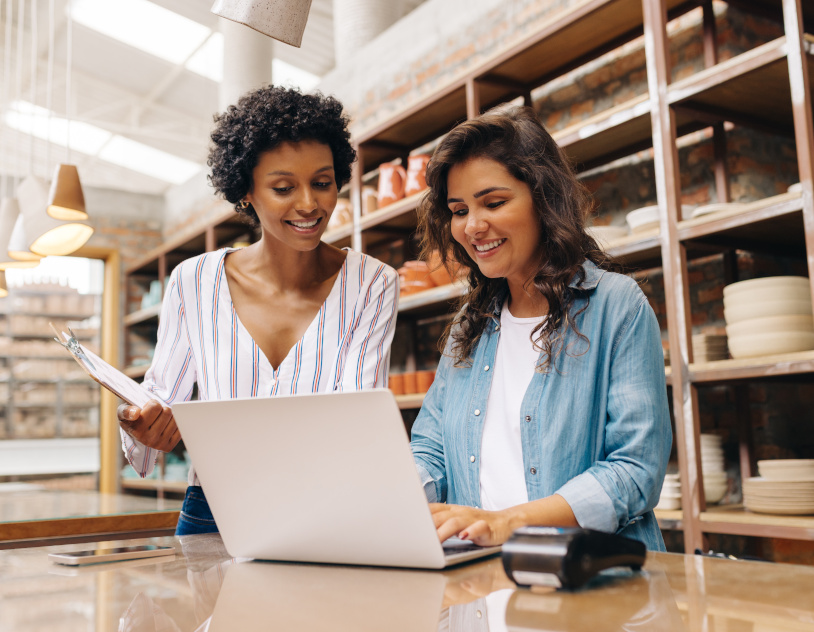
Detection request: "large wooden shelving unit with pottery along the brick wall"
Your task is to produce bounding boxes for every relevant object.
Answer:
[116,0,814,552]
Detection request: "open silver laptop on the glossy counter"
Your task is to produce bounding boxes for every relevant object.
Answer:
[173,389,500,568]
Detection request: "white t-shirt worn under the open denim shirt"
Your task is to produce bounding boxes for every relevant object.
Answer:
[480,300,541,511]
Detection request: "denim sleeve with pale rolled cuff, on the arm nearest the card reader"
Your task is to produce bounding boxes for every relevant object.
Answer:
[556,293,672,533]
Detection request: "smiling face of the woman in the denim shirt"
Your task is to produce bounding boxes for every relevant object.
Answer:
[447,157,541,287]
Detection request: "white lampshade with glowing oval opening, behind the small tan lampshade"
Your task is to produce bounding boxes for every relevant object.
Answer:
[12,176,93,256]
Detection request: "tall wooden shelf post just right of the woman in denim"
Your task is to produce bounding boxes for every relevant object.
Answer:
[642,0,704,553]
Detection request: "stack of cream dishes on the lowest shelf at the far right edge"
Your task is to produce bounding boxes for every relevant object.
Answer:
[743,459,814,515]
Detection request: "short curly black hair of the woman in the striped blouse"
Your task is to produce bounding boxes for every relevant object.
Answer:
[206,85,356,225]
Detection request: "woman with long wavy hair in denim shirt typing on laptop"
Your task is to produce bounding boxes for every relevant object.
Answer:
[411,107,672,550]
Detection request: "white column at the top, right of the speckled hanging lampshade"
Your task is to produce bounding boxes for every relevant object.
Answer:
[333,0,403,67]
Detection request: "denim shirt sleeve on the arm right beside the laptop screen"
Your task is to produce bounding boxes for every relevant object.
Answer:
[410,355,451,503]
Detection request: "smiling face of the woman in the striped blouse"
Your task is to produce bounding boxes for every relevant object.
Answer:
[245,140,338,251]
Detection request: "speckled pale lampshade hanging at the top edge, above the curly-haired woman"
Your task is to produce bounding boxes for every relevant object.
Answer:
[211,0,311,48]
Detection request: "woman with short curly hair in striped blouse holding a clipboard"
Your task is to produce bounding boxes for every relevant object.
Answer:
[118,86,398,535]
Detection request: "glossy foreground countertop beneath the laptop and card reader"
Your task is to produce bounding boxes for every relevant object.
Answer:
[0,535,814,632]
